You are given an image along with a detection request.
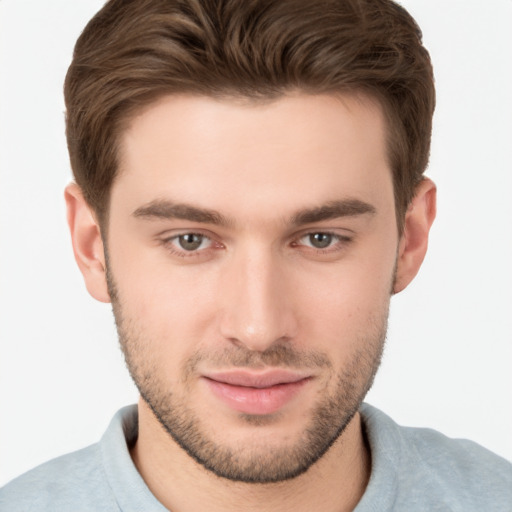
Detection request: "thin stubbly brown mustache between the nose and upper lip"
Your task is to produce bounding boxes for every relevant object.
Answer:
[185,343,332,374]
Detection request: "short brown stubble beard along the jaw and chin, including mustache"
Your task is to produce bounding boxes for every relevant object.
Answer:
[108,266,388,484]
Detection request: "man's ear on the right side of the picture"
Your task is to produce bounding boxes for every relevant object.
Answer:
[393,178,436,293]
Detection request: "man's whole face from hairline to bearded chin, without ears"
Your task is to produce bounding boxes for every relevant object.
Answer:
[106,94,398,482]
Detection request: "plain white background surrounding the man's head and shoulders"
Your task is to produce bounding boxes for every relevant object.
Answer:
[0,0,512,485]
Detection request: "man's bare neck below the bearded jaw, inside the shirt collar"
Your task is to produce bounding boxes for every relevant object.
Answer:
[131,400,370,512]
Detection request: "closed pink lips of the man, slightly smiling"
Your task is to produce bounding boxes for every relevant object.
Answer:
[203,370,312,415]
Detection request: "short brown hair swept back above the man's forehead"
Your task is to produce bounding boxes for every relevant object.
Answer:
[65,0,435,229]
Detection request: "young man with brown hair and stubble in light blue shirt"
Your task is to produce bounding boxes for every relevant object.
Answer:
[0,1,512,510]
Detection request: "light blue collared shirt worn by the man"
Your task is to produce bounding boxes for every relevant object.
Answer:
[0,404,512,512]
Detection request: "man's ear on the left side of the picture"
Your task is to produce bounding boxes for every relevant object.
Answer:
[64,183,110,302]
